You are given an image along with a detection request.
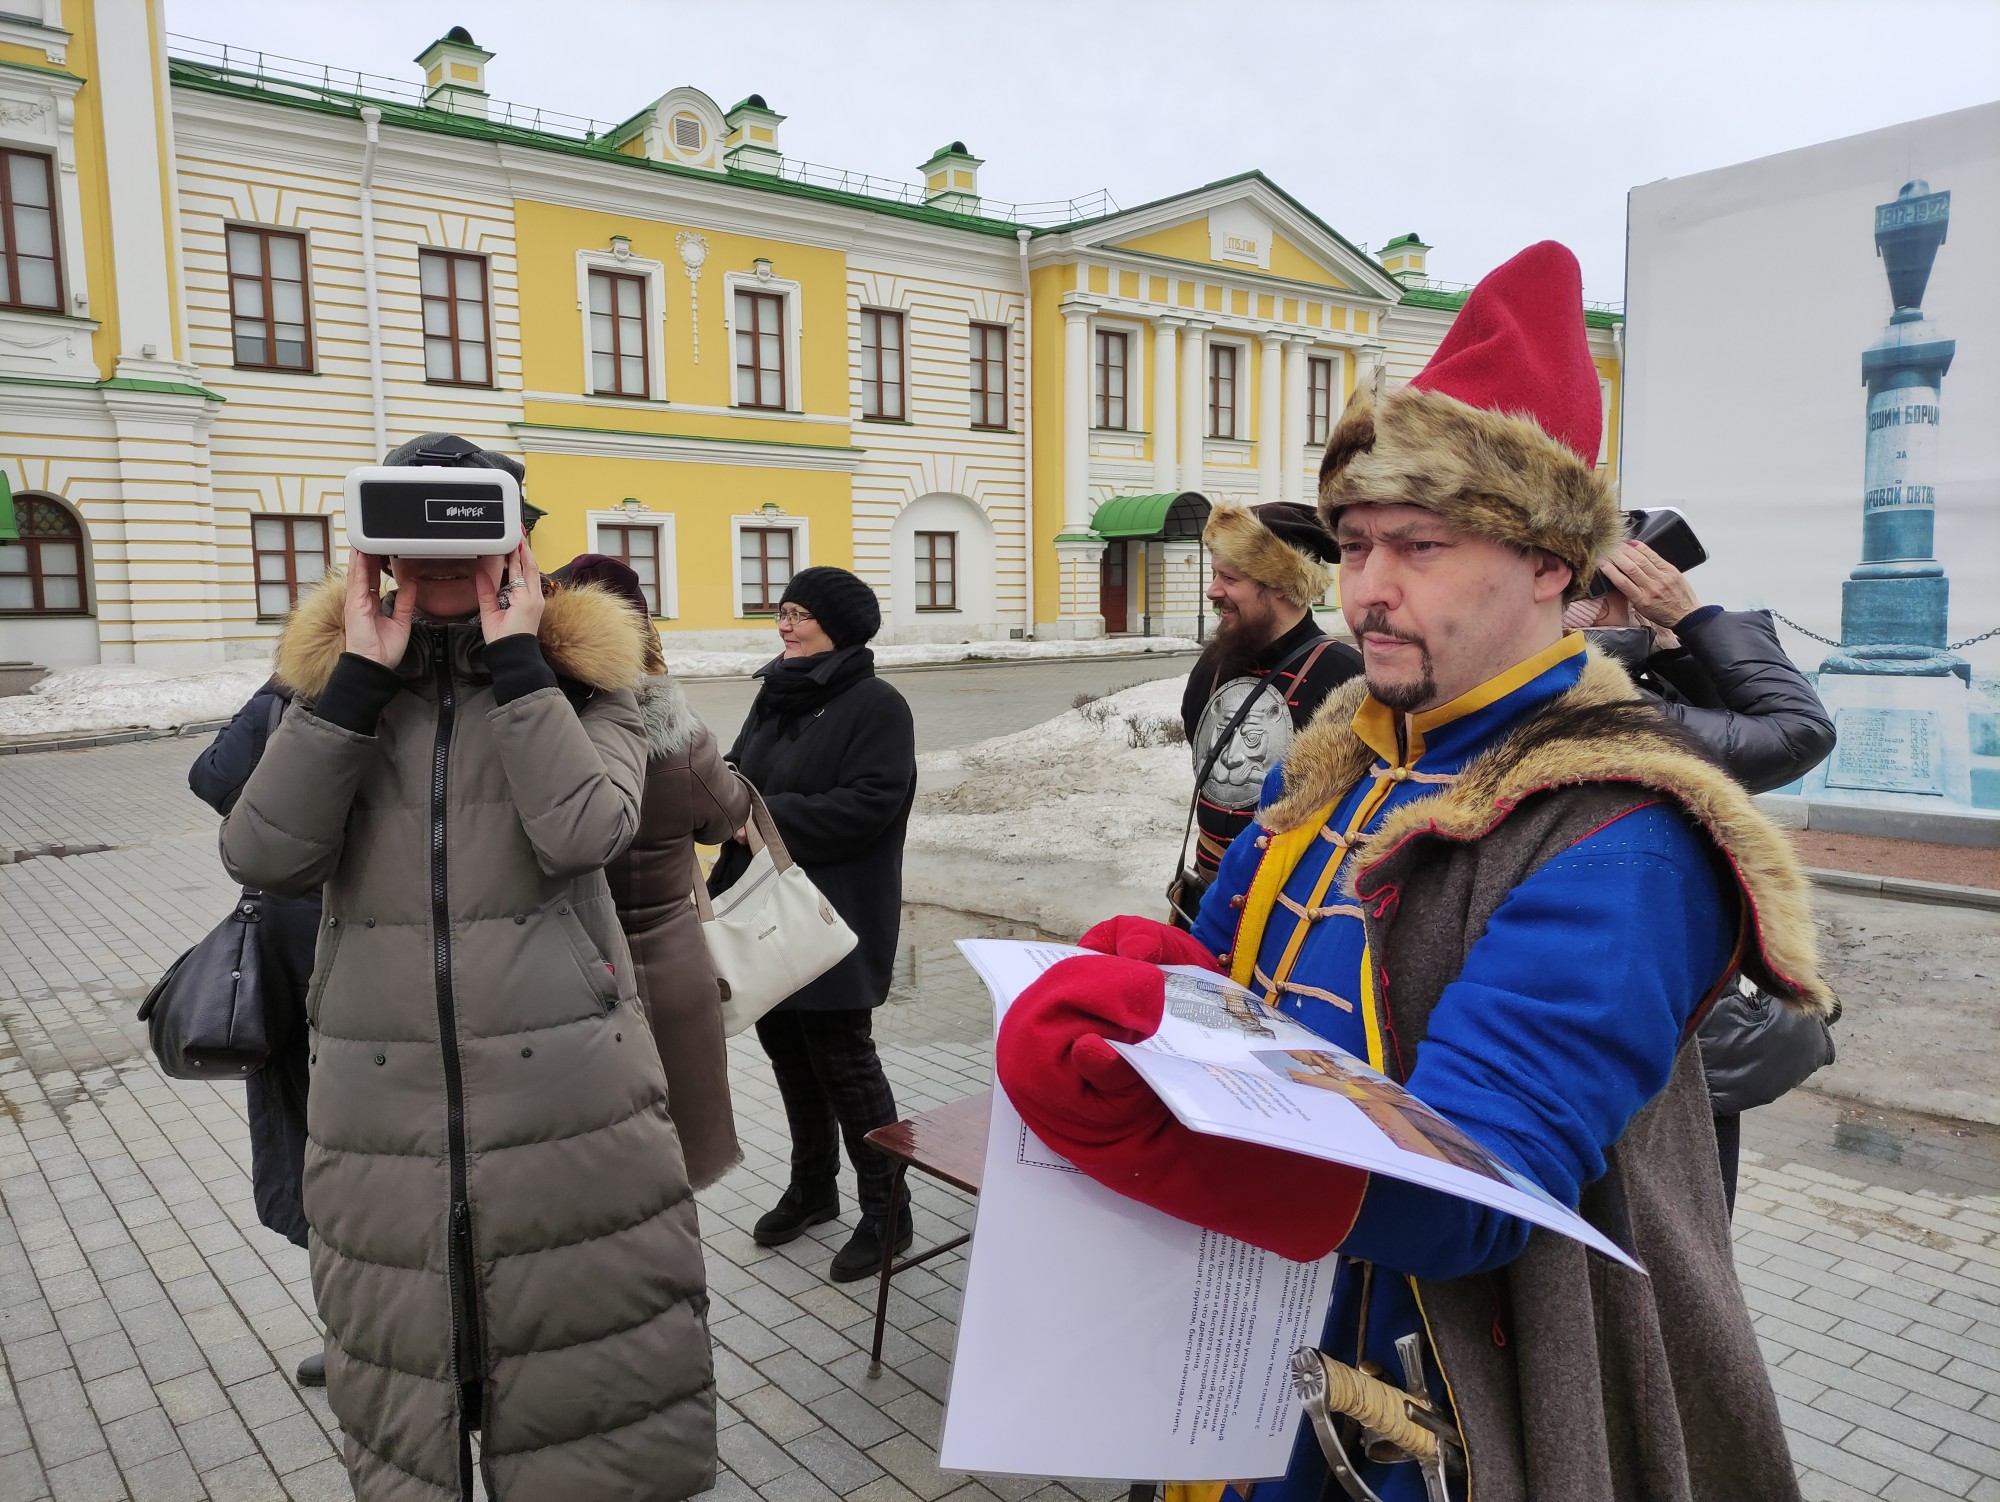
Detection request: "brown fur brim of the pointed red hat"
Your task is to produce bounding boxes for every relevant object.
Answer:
[1320,386,1624,600]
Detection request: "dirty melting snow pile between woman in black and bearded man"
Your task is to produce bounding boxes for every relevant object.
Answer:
[910,676,1194,890]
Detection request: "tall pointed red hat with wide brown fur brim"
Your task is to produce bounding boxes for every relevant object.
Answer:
[1320,240,1624,600]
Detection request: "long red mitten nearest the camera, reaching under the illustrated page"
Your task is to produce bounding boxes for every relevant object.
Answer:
[994,956,1368,1262]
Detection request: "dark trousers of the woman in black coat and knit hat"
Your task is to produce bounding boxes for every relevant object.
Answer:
[756,1006,908,1232]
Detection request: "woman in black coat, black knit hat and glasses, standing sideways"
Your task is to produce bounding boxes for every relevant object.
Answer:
[708,568,916,1282]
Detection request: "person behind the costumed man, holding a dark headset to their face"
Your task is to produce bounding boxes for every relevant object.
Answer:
[1562,512,1838,1210]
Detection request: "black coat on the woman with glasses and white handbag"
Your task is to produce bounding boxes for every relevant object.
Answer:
[708,646,916,1012]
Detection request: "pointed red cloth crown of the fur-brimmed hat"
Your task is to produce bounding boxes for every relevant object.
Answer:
[1410,240,1604,464]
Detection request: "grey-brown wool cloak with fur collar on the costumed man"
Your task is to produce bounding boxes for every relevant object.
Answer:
[1260,652,1832,1502]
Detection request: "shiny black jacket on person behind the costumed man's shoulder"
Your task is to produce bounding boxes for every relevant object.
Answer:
[1638,610,1838,1116]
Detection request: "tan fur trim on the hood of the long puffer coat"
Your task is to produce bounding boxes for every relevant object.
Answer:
[276,574,646,698]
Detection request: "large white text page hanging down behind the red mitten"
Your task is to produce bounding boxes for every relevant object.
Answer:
[938,940,1336,1482]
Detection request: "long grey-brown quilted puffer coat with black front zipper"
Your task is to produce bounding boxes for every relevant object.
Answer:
[222,578,716,1502]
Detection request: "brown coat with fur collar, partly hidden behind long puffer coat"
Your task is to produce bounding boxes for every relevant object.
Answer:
[604,674,750,1188]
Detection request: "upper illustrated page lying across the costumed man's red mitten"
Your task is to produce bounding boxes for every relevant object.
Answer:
[1112,966,1644,1272]
